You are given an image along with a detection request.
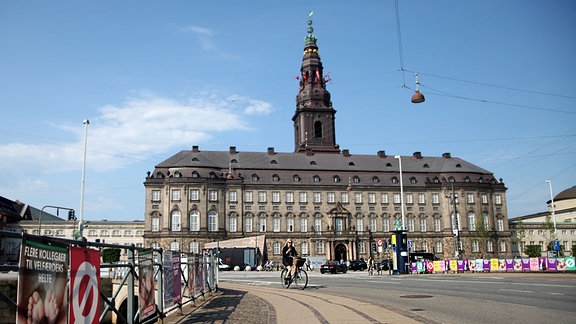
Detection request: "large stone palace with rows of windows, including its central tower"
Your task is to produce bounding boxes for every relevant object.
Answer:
[144,17,512,262]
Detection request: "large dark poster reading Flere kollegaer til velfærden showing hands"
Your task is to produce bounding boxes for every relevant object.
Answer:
[16,235,68,324]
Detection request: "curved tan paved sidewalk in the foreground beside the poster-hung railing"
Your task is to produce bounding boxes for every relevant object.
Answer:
[163,283,423,324]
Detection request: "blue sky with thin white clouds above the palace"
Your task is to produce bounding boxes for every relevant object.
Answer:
[0,0,576,221]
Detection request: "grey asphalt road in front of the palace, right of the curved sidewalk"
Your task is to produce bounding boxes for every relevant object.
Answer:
[220,271,576,324]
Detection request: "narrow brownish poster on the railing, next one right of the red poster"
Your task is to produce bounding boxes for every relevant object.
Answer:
[138,249,156,321]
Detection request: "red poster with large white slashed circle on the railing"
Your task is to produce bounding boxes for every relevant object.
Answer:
[68,247,100,324]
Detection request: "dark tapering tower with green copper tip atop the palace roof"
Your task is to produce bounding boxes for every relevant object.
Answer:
[292,11,340,153]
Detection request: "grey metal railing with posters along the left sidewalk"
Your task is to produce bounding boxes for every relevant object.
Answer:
[0,231,218,324]
